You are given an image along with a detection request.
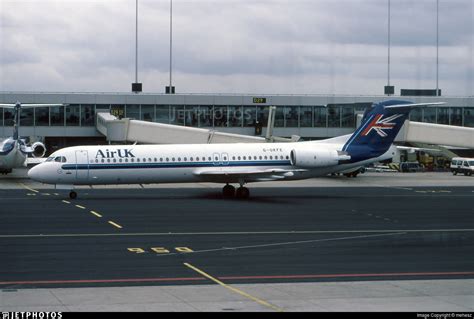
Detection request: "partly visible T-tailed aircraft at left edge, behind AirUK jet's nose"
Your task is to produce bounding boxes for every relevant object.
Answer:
[0,102,63,175]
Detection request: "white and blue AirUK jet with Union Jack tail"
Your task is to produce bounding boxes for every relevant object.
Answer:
[28,100,443,199]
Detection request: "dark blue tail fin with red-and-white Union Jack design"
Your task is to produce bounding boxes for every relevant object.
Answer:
[342,100,444,162]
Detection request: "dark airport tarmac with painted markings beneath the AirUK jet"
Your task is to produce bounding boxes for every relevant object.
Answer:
[0,171,474,312]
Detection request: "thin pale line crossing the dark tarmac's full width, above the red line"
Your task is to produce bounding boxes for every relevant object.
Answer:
[0,229,474,238]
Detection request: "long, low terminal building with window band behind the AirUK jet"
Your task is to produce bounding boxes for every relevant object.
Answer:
[0,92,474,158]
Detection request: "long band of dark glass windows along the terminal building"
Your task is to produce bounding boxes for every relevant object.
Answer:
[0,103,474,132]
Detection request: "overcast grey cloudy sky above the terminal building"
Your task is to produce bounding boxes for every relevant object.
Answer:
[0,0,474,96]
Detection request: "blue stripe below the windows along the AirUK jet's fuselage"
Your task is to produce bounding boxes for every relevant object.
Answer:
[61,160,291,170]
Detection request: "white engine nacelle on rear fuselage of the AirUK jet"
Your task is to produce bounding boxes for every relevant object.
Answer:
[290,148,350,168]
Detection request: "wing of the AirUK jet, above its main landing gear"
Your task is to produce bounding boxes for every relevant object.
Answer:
[194,167,307,183]
